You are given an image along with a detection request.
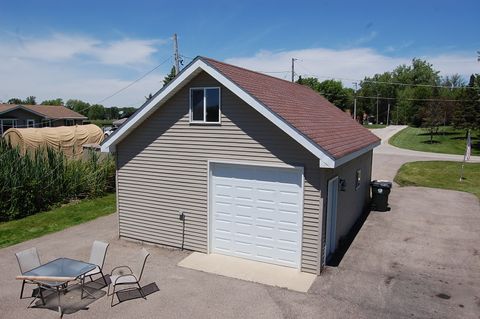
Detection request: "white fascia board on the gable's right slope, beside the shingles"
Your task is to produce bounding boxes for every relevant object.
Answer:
[199,60,335,168]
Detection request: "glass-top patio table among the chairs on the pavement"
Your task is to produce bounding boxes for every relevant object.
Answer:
[22,258,97,316]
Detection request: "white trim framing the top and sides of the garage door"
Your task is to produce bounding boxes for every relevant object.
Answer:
[207,160,305,271]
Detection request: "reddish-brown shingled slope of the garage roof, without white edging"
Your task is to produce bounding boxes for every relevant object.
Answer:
[200,57,379,159]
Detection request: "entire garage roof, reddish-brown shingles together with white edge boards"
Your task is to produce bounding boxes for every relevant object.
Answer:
[102,57,380,168]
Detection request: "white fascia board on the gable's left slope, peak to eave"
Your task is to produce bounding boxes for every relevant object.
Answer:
[101,60,204,153]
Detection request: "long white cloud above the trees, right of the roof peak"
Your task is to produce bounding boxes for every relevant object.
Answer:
[226,48,480,86]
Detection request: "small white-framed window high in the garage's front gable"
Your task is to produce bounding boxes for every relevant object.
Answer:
[190,87,220,123]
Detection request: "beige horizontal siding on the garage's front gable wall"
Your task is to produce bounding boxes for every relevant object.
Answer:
[117,73,321,273]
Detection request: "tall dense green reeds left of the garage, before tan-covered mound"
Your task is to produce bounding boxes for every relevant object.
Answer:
[0,140,115,221]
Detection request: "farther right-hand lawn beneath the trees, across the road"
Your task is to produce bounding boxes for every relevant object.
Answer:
[389,126,480,155]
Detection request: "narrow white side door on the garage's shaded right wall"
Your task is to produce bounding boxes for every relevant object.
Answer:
[324,176,339,264]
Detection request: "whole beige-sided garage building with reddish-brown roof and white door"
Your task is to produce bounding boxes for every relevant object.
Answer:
[102,57,379,274]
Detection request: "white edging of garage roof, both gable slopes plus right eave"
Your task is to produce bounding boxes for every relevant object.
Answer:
[101,57,378,168]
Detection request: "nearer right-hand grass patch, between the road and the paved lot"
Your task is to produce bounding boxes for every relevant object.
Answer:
[395,161,480,199]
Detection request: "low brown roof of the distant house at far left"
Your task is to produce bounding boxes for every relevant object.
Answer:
[0,104,87,120]
